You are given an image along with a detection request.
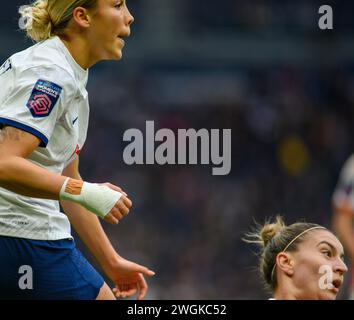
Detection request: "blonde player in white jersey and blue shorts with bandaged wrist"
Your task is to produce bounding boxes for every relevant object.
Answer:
[0,0,154,299]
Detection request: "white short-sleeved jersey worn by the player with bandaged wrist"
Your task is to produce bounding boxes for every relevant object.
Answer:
[0,37,89,240]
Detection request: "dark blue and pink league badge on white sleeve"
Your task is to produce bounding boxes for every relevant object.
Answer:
[27,80,62,118]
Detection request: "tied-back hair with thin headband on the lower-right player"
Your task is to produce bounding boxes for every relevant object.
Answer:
[243,216,325,292]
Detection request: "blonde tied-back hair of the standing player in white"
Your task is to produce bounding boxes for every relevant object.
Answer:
[20,0,98,42]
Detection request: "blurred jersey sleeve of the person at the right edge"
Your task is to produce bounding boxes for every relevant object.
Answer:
[332,155,354,215]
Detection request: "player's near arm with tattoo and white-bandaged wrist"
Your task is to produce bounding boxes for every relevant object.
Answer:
[0,126,130,224]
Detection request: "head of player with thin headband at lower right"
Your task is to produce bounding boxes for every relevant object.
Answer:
[246,217,348,300]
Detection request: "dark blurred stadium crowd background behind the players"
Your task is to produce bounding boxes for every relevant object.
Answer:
[0,0,354,299]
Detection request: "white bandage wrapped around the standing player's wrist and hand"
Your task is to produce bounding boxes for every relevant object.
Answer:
[60,178,122,218]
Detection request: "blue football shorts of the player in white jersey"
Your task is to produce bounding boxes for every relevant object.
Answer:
[0,236,104,300]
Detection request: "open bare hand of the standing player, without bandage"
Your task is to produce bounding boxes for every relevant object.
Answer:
[107,257,155,300]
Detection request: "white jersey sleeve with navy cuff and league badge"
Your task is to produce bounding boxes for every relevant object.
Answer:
[0,62,75,147]
